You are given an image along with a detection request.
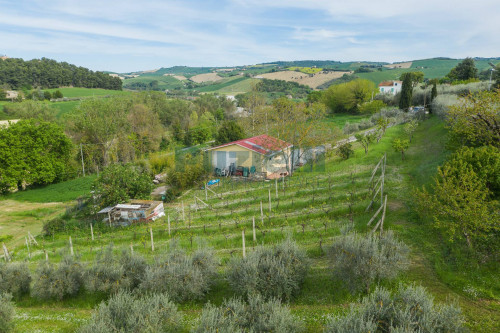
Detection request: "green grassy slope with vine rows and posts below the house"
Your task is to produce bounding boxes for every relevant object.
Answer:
[4,119,500,332]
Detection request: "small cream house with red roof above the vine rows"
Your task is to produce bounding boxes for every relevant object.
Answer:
[206,134,293,178]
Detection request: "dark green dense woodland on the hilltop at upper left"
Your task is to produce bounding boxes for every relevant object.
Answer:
[0,58,122,90]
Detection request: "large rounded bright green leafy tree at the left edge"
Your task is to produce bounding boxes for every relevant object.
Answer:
[0,119,73,192]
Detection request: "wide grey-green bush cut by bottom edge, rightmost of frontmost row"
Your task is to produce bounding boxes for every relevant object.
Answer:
[325,285,465,333]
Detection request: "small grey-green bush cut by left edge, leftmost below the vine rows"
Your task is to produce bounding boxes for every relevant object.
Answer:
[0,262,31,297]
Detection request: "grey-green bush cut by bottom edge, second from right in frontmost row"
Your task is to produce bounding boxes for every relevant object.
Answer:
[192,295,303,333]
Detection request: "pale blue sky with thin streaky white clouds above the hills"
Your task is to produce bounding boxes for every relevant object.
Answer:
[0,0,500,73]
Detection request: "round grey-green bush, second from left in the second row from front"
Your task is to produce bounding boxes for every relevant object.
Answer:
[32,256,84,300]
